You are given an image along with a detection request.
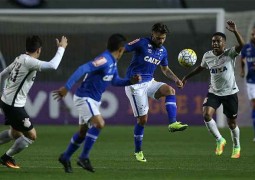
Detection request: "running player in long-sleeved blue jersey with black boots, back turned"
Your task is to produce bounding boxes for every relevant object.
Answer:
[54,34,141,173]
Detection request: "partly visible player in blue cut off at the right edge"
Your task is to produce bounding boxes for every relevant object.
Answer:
[240,27,255,142]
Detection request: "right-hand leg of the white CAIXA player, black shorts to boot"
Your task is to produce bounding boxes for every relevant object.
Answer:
[223,94,241,158]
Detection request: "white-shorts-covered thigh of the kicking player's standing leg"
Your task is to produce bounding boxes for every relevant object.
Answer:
[125,82,149,117]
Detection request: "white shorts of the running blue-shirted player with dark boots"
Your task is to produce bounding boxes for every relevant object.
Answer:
[73,95,101,125]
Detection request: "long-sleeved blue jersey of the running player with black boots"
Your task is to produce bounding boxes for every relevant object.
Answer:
[65,51,131,101]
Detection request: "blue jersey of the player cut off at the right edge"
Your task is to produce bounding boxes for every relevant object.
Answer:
[241,43,255,84]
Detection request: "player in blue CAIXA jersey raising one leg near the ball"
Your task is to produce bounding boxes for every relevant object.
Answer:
[125,23,188,162]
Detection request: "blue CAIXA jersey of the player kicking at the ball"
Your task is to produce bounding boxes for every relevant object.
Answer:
[125,38,168,83]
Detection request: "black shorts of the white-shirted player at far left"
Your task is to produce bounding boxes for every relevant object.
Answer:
[2,103,34,132]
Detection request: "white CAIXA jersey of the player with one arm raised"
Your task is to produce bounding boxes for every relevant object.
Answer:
[201,47,239,96]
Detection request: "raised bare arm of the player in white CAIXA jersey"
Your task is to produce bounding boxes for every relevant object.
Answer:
[226,20,245,53]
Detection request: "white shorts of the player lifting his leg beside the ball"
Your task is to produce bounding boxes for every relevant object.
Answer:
[125,79,165,117]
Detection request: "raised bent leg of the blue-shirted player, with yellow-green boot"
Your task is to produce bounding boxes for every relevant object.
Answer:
[148,80,188,132]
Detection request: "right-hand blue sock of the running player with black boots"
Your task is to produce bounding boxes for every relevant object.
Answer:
[80,126,100,159]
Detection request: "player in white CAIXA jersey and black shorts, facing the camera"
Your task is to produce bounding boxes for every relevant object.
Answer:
[182,20,244,158]
